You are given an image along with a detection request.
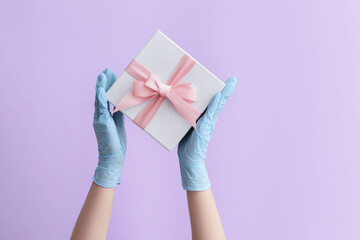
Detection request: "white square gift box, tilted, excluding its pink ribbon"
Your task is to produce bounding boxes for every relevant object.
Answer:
[107,30,224,151]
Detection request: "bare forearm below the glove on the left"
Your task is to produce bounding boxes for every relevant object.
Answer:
[71,182,114,240]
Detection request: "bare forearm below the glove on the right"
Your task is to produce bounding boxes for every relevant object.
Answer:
[187,189,226,240]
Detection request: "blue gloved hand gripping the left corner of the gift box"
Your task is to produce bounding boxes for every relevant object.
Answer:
[93,69,126,188]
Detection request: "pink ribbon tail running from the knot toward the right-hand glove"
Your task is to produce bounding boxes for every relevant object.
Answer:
[167,93,200,129]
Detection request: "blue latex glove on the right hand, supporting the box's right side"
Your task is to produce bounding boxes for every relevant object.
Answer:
[178,77,237,191]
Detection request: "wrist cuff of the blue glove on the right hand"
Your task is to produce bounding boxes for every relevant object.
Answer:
[180,161,211,191]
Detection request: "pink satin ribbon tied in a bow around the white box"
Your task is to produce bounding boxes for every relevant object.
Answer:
[114,54,200,129]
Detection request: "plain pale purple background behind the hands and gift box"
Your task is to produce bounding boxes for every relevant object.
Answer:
[0,0,360,240]
